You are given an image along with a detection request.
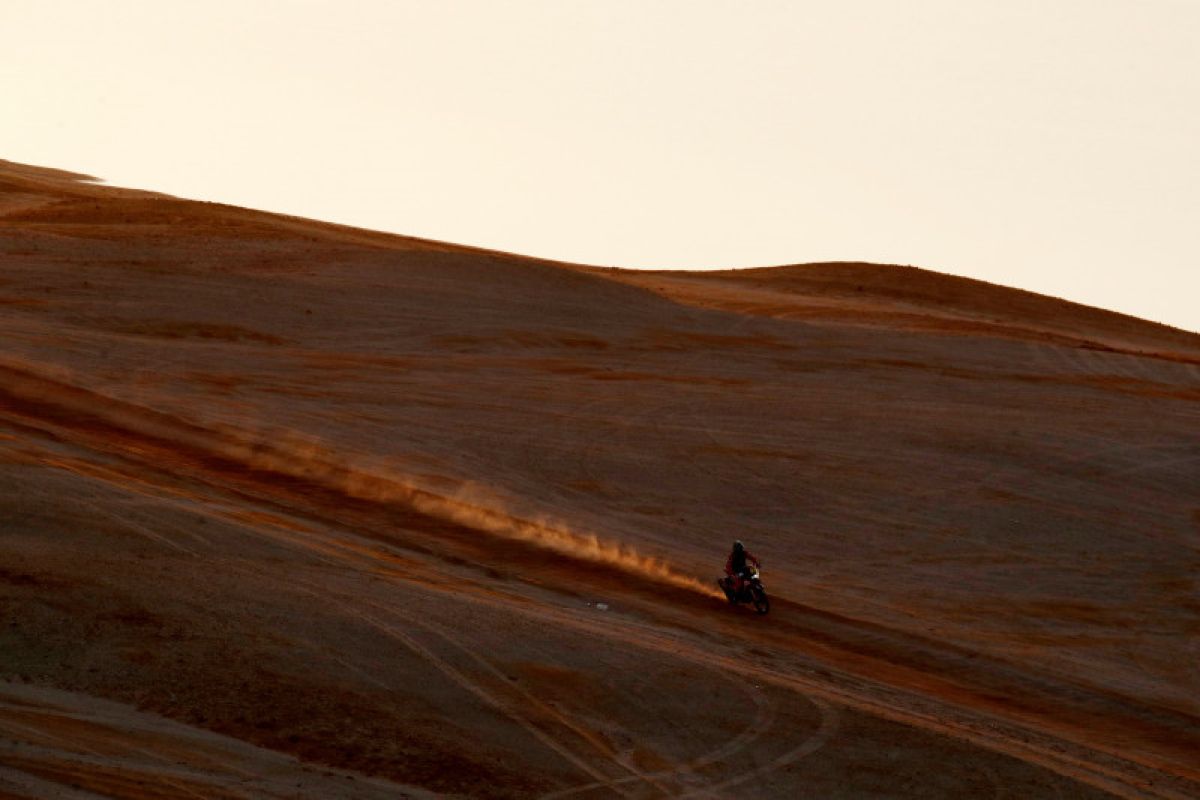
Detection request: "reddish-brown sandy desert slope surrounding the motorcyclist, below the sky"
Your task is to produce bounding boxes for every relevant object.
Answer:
[0,162,1200,798]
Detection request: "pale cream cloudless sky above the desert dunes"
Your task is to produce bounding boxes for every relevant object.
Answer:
[0,0,1200,331]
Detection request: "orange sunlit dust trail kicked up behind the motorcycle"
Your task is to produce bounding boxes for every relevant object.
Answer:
[0,359,716,596]
